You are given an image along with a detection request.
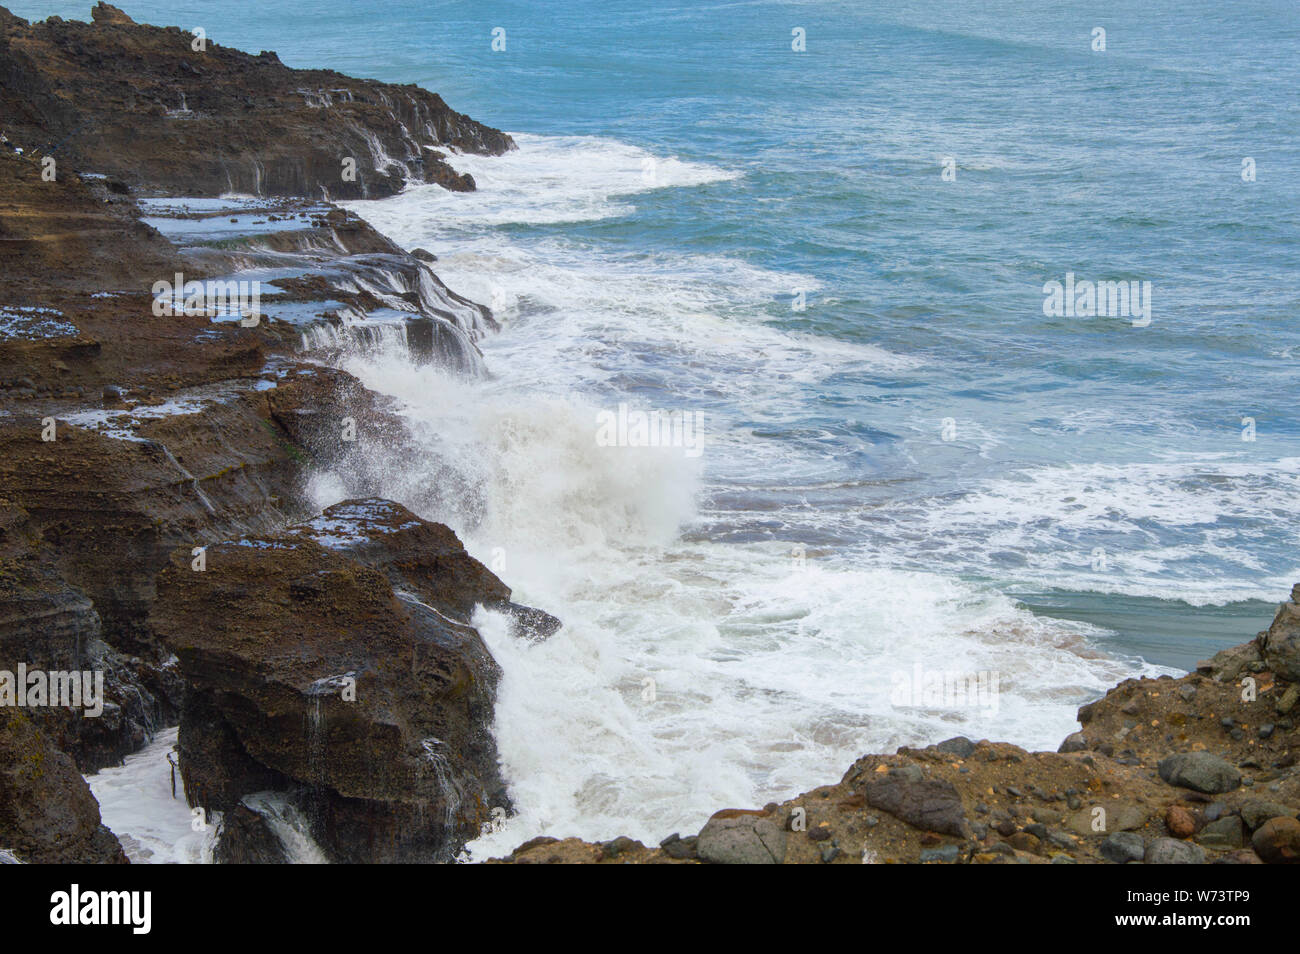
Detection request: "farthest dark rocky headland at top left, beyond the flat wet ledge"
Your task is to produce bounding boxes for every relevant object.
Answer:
[0,4,514,199]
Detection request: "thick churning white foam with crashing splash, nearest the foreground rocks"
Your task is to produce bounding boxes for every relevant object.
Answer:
[316,355,1170,858]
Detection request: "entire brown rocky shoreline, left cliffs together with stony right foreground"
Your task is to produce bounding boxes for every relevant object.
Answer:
[0,4,1300,863]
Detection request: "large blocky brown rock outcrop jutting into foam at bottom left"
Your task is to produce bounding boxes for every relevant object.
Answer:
[152,502,508,862]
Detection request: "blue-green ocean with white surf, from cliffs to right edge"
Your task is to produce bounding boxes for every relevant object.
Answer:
[22,0,1300,858]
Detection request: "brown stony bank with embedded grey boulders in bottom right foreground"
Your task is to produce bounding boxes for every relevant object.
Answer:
[497,616,1300,864]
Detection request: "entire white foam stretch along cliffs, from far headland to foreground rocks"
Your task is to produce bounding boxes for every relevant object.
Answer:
[313,130,1190,858]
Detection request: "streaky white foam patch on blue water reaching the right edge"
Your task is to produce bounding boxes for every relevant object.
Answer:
[872,455,1300,606]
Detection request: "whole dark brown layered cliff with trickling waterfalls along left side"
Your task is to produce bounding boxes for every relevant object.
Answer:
[0,4,540,862]
